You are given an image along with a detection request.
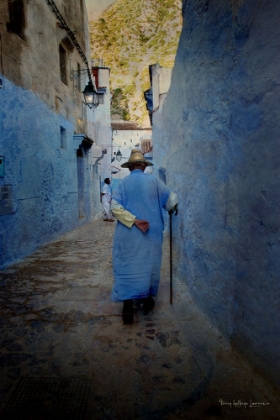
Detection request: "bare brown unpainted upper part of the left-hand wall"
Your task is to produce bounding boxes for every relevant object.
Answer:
[0,0,89,122]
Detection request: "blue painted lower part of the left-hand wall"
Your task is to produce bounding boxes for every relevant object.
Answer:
[0,78,95,268]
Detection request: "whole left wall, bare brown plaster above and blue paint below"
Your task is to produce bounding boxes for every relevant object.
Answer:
[0,0,101,268]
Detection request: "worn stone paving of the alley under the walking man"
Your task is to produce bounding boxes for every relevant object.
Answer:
[0,220,280,420]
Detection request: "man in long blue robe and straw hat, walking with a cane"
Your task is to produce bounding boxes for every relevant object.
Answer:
[111,149,178,323]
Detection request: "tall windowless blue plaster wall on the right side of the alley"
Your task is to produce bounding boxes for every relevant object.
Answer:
[153,0,280,387]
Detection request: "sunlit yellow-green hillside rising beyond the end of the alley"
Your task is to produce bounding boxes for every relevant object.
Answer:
[90,0,182,126]
